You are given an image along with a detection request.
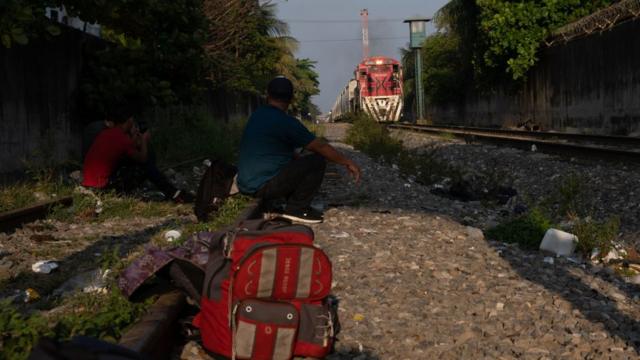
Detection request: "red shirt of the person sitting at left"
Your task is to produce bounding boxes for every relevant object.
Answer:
[82,127,137,188]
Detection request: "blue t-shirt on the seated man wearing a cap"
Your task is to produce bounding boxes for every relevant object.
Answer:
[238,105,315,194]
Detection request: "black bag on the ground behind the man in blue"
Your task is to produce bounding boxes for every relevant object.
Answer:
[193,160,238,222]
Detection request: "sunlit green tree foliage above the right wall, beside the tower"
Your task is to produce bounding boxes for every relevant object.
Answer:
[404,0,613,105]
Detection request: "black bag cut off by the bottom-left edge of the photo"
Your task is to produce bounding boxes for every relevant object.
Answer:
[28,336,146,360]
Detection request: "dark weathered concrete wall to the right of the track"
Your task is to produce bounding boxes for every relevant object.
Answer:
[427,19,640,135]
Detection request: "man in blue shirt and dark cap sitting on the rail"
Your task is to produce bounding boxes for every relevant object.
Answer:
[238,77,360,223]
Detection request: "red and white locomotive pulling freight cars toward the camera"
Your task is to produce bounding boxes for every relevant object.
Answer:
[330,57,403,122]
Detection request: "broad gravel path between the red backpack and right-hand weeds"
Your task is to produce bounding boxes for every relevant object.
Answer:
[315,125,640,360]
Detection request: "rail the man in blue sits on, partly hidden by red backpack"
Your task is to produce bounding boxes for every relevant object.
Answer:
[118,201,262,359]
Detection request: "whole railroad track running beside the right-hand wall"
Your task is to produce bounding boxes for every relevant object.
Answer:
[387,124,640,163]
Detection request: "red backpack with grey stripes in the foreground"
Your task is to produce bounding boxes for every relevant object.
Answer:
[194,222,339,360]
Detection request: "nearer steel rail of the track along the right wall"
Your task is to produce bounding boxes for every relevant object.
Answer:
[387,124,640,163]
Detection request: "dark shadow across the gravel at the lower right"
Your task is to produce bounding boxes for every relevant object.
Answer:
[489,242,640,354]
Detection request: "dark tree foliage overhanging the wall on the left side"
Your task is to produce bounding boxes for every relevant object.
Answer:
[0,0,318,114]
